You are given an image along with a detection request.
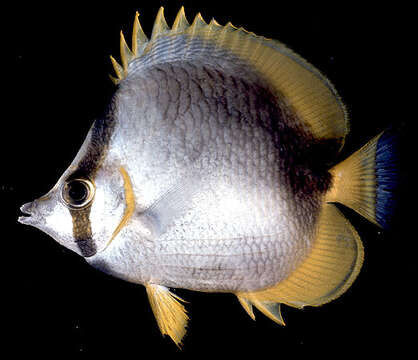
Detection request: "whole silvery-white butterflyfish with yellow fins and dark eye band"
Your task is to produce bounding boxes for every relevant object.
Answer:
[18,7,399,347]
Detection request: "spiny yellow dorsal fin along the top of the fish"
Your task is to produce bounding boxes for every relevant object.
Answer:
[111,7,349,146]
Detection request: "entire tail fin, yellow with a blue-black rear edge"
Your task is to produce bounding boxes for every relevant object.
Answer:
[326,131,399,228]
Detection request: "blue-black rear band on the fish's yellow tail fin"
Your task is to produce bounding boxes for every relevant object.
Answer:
[375,129,400,229]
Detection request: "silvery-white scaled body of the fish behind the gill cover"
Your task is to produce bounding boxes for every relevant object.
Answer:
[88,59,321,291]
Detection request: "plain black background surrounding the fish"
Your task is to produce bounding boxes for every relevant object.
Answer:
[0,0,417,358]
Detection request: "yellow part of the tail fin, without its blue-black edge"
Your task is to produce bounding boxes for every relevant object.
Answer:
[325,133,383,225]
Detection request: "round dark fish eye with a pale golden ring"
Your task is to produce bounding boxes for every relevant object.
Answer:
[62,179,94,208]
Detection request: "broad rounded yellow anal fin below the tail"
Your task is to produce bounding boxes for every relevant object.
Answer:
[236,204,363,310]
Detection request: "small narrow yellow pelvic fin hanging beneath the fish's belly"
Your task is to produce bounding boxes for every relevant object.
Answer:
[145,284,189,347]
